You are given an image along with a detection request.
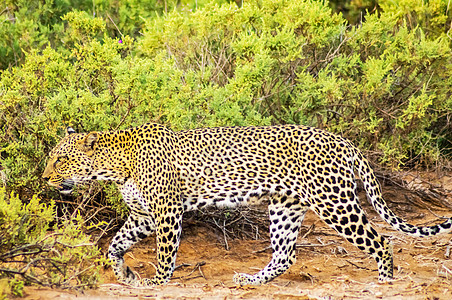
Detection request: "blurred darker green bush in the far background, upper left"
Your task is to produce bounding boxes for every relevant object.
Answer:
[0,0,233,70]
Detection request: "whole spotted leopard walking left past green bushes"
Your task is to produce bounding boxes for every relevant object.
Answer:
[42,123,452,286]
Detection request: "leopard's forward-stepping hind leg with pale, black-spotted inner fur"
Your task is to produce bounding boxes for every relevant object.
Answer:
[233,196,307,285]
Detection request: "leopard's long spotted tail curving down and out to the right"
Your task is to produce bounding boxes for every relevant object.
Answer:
[354,148,452,237]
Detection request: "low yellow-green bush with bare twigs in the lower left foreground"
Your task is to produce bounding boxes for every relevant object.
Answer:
[0,188,106,298]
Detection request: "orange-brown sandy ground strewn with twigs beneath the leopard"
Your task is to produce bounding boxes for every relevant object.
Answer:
[22,186,452,300]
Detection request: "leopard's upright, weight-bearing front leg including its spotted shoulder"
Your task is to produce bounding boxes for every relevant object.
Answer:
[133,140,183,285]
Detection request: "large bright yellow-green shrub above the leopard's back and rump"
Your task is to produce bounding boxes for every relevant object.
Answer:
[139,0,451,168]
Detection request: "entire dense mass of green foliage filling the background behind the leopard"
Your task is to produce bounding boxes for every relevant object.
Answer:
[0,0,452,292]
